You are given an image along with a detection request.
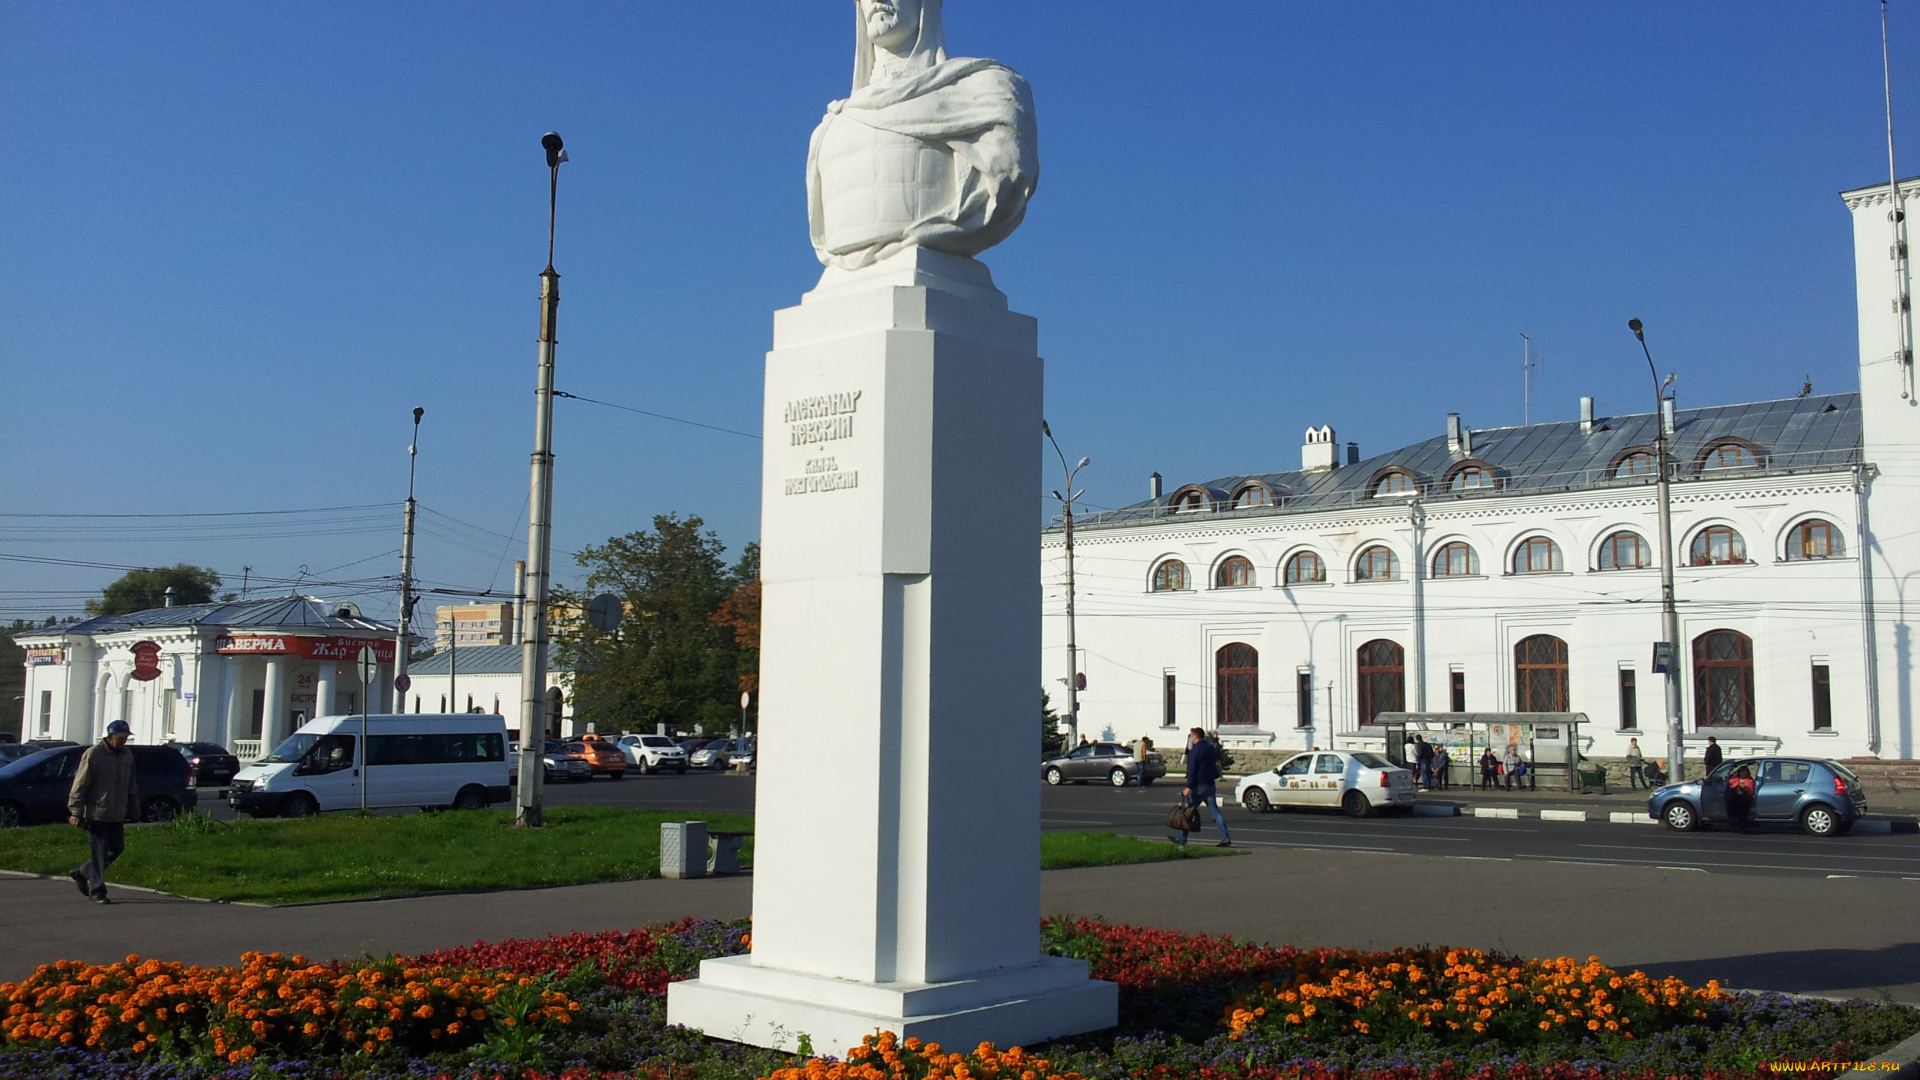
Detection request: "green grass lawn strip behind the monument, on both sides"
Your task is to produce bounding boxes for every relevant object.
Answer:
[0,807,1225,903]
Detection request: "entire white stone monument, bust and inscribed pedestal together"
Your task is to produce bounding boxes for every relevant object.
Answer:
[668,0,1117,1053]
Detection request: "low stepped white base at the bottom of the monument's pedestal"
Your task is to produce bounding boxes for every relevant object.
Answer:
[666,957,1119,1057]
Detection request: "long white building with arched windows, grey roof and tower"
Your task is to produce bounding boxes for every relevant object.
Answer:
[1041,181,1920,761]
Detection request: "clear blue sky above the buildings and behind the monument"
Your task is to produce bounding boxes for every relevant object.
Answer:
[0,0,1920,619]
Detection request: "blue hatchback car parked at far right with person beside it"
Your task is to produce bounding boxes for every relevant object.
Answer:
[1647,757,1866,836]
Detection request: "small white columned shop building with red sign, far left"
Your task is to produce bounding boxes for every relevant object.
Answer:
[15,596,394,755]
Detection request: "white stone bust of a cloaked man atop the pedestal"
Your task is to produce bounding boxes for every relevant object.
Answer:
[806,0,1041,269]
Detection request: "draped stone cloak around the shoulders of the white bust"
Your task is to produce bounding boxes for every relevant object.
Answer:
[806,56,1041,269]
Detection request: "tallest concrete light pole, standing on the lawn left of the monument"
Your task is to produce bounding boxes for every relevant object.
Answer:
[514,131,566,828]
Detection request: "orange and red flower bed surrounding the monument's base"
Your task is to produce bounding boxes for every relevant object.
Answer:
[0,919,1920,1080]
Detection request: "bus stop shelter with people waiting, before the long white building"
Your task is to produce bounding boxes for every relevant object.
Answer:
[1369,713,1588,792]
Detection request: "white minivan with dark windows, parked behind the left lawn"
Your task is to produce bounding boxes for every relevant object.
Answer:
[227,713,513,817]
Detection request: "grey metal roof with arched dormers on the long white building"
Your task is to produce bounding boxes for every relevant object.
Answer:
[1048,394,1860,530]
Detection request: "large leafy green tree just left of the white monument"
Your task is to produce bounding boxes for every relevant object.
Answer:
[553,513,739,730]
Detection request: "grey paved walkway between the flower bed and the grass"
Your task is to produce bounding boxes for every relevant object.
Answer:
[0,847,1920,1001]
